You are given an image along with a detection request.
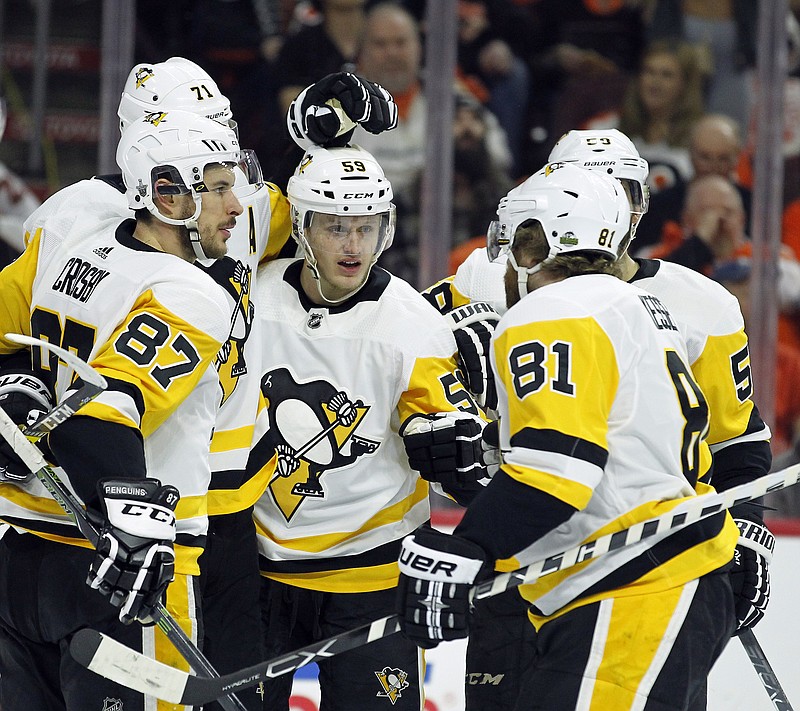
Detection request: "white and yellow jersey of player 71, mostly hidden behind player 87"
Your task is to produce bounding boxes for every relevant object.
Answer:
[25,175,294,515]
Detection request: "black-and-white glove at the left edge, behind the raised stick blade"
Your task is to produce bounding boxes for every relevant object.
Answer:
[0,370,53,482]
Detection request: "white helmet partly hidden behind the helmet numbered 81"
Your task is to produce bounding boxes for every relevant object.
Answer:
[547,128,650,247]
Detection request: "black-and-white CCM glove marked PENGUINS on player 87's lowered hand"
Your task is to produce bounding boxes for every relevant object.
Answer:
[86,479,180,624]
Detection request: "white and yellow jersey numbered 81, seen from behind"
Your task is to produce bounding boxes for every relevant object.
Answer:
[462,275,738,615]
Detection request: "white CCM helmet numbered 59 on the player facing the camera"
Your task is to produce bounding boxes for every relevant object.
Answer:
[286,145,395,298]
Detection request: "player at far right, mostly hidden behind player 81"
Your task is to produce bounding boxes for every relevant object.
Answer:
[454,129,772,711]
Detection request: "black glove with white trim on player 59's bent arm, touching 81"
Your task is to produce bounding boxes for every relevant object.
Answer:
[400,411,487,486]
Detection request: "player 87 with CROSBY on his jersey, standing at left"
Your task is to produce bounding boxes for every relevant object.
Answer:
[0,111,253,711]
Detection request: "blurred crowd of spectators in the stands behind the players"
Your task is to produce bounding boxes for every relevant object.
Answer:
[0,0,800,511]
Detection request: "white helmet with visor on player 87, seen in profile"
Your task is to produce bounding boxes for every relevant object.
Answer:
[117,111,262,259]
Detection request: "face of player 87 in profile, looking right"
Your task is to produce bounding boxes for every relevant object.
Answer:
[197,165,242,259]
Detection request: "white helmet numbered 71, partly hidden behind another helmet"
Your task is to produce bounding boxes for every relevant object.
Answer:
[117,57,236,131]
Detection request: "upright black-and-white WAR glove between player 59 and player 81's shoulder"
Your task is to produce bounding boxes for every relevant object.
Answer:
[445,301,500,410]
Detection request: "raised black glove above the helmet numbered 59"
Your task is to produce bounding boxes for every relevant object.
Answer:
[286,72,397,150]
